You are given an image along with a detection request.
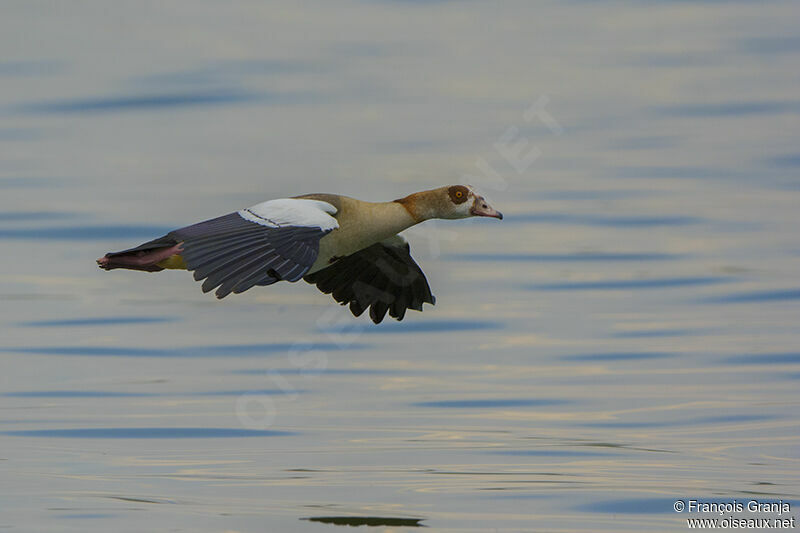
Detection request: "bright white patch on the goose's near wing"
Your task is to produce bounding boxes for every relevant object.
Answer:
[238,198,339,230]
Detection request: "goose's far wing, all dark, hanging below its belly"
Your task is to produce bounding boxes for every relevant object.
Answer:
[303,235,436,324]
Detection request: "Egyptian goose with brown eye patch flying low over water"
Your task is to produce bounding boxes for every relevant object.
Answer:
[97,185,503,324]
